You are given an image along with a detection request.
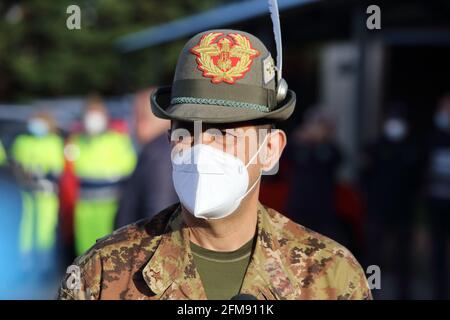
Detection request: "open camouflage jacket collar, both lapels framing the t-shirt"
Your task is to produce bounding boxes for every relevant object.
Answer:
[143,204,295,300]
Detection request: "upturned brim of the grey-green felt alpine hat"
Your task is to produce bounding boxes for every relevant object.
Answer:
[151,86,296,123]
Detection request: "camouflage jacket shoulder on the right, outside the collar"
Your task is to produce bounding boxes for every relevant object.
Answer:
[267,209,371,299]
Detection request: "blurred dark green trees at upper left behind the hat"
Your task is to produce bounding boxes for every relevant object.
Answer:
[0,0,221,101]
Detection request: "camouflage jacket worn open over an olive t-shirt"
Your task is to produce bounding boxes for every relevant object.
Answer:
[59,204,372,299]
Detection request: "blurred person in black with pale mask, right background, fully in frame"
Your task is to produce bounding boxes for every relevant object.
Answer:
[362,103,421,299]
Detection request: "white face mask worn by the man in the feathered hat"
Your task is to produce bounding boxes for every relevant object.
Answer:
[172,135,267,219]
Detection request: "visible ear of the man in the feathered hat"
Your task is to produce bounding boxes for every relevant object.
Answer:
[261,129,287,173]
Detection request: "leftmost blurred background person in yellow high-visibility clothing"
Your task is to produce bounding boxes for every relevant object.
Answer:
[11,112,64,276]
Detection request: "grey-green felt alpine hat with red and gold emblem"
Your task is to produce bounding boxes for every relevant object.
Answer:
[151,30,296,123]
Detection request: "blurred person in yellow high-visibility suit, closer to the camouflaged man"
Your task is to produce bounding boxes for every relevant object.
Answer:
[66,96,136,255]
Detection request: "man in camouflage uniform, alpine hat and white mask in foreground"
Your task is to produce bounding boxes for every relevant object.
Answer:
[59,30,371,299]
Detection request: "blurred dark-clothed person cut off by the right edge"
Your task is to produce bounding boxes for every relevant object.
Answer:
[426,93,450,299]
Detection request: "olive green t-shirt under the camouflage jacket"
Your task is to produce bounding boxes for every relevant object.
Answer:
[191,239,253,300]
